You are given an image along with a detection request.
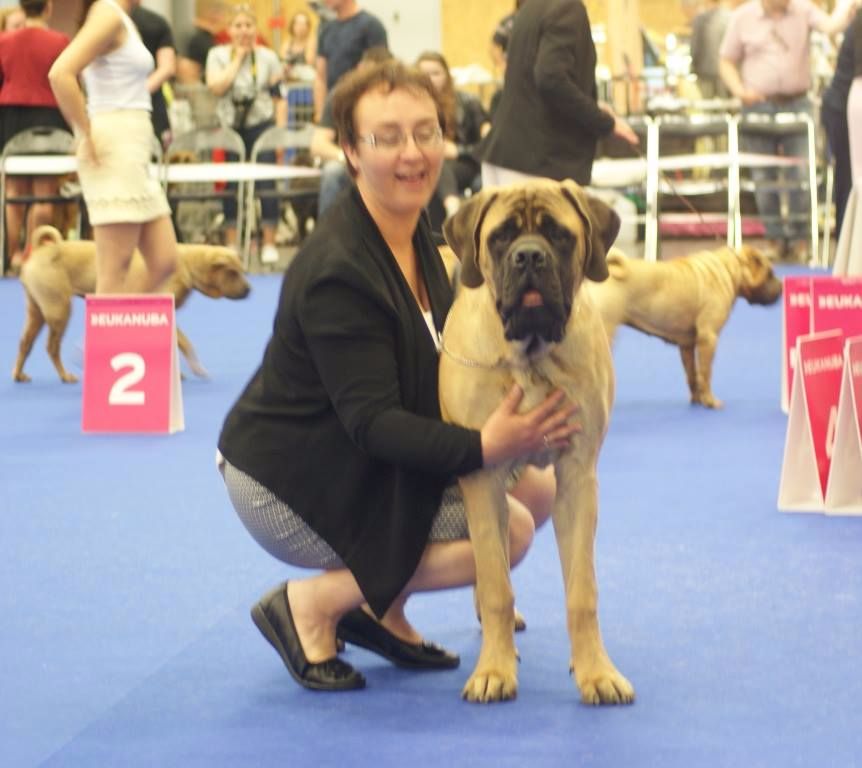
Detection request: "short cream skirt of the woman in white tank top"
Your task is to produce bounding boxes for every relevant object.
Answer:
[78,109,171,225]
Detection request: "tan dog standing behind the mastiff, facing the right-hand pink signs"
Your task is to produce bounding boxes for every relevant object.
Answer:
[589,246,781,408]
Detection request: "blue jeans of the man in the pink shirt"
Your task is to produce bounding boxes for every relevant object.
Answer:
[739,96,812,240]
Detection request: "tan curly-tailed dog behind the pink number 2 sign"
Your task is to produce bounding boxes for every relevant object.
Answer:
[12,226,251,383]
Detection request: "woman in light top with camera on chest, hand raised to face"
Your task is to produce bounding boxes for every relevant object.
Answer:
[206,5,284,263]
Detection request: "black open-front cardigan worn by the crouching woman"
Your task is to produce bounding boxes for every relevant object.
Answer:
[219,188,482,616]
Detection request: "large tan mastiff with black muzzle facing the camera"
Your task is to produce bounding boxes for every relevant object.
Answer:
[440,180,634,704]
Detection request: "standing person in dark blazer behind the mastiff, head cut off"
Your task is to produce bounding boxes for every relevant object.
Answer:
[482,0,638,186]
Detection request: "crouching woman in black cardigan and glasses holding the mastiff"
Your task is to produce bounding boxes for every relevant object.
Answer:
[219,61,577,690]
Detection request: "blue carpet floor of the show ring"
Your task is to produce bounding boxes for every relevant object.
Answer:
[0,266,862,768]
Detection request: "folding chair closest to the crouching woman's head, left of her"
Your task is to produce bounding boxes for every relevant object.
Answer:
[243,123,320,263]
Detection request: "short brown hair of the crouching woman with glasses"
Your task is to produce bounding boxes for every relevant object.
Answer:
[332,59,445,172]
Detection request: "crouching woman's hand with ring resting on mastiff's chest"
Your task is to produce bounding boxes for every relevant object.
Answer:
[481,384,581,467]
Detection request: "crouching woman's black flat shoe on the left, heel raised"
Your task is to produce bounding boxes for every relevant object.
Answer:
[251,582,365,691]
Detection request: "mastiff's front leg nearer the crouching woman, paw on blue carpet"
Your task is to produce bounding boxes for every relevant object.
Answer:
[459,472,518,702]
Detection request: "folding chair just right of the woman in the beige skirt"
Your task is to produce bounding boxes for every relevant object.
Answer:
[163,127,246,243]
